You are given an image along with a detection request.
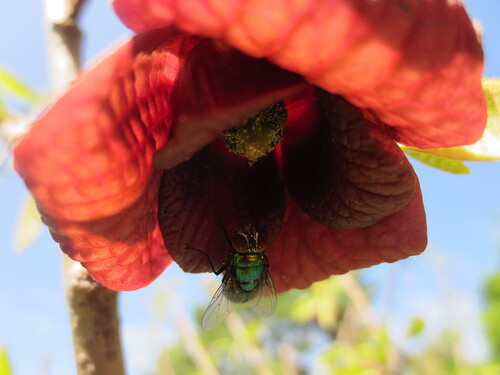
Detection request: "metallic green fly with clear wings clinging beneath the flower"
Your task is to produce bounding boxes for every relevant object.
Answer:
[189,224,276,329]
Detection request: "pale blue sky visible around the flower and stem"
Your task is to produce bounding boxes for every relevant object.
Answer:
[0,0,500,375]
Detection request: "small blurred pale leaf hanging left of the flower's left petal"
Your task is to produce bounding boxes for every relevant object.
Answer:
[14,195,42,253]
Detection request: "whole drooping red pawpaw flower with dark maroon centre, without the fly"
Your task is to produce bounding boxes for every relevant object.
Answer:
[14,0,486,292]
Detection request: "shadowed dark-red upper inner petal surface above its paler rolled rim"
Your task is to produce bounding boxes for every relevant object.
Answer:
[171,39,305,121]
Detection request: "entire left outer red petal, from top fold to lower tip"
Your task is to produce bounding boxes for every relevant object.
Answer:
[14,30,198,290]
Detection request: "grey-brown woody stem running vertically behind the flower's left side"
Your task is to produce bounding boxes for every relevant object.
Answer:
[44,0,125,375]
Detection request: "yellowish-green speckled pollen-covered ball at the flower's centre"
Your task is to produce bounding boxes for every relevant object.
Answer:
[221,101,288,165]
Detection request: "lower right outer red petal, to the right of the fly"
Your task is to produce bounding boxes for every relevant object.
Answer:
[266,182,427,292]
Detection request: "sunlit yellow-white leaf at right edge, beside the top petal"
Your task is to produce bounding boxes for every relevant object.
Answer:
[401,78,500,161]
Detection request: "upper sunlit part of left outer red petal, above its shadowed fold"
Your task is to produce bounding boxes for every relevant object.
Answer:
[14,31,195,221]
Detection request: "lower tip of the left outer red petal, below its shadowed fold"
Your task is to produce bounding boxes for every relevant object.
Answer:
[42,171,168,290]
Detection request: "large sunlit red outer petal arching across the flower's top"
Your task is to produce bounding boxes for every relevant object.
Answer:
[114,0,486,148]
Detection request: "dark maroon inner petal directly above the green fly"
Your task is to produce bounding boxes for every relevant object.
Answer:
[158,141,285,272]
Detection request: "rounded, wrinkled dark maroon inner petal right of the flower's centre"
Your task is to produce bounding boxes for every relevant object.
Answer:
[281,89,415,229]
